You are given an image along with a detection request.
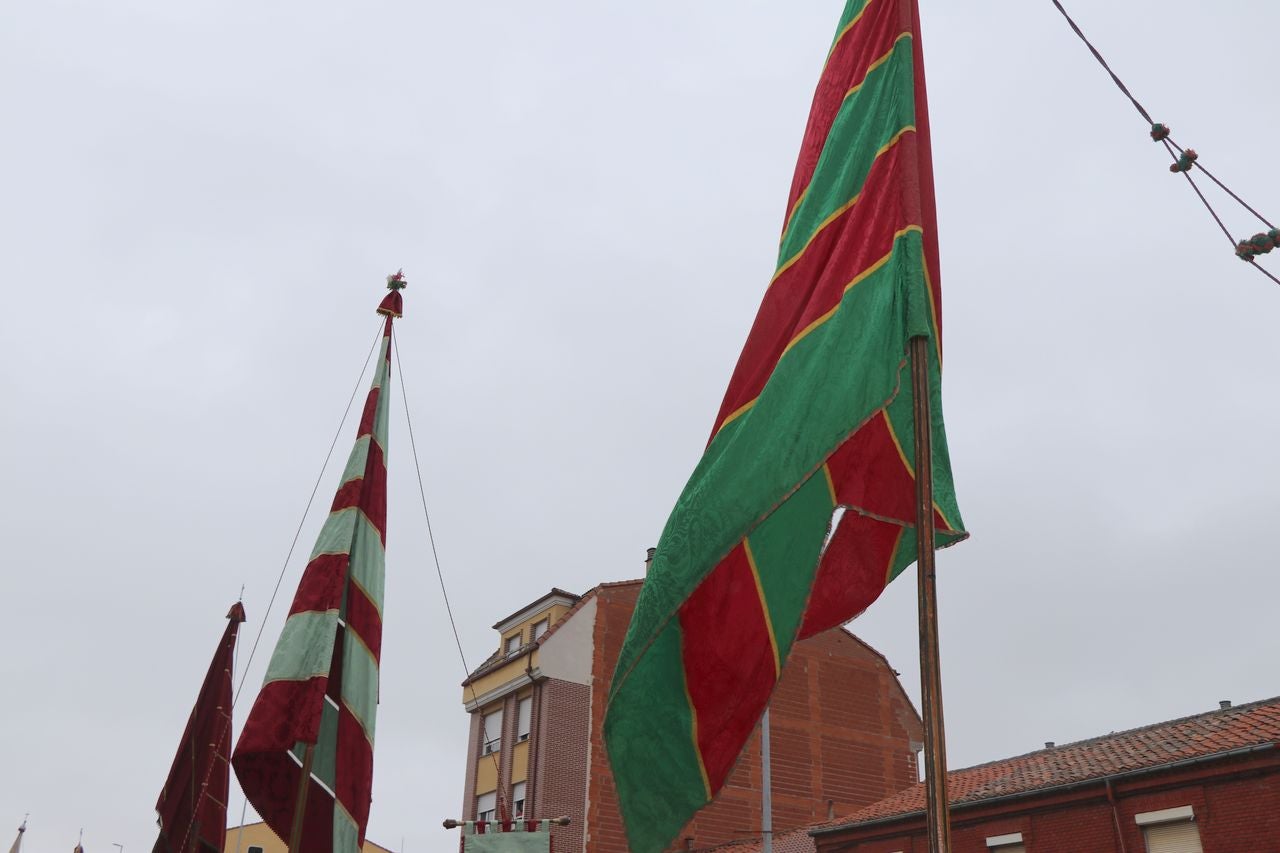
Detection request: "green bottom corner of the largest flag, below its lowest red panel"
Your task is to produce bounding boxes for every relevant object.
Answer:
[604,619,707,853]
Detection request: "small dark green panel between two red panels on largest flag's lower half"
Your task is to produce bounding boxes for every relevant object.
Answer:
[748,471,836,661]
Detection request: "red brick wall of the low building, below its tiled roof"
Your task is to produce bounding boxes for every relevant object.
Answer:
[817,749,1280,853]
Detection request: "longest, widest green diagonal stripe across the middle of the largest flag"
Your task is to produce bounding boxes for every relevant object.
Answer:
[614,232,923,689]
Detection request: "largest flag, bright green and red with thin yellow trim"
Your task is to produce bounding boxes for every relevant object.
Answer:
[604,0,966,853]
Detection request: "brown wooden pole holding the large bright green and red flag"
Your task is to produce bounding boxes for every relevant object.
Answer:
[910,337,951,853]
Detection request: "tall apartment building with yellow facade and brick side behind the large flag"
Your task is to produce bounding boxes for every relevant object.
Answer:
[462,580,922,853]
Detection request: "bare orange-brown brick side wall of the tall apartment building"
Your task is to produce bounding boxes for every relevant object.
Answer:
[586,584,922,853]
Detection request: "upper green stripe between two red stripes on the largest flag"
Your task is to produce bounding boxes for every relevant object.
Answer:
[778,38,915,266]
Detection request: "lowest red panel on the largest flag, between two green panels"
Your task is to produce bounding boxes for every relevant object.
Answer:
[680,544,777,792]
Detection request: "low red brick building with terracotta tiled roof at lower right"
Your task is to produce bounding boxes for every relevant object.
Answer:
[796,697,1280,853]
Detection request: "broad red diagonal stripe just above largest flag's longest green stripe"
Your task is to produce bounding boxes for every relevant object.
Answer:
[708,132,920,443]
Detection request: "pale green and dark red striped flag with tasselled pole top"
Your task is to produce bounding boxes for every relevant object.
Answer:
[232,273,404,853]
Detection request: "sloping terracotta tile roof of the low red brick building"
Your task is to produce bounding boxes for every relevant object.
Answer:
[813,697,1280,830]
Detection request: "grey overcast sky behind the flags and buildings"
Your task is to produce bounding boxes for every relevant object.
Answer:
[0,0,1280,853]
